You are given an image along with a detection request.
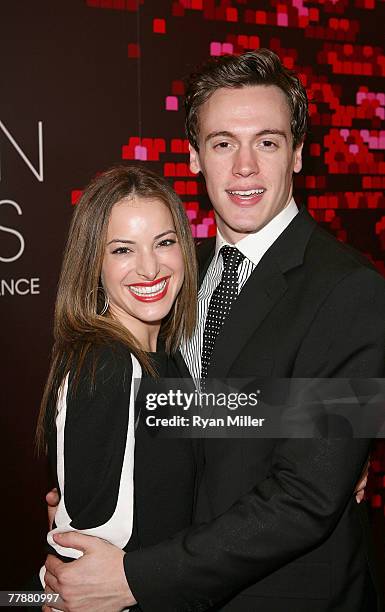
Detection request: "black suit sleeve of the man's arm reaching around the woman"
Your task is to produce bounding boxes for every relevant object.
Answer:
[124,268,385,612]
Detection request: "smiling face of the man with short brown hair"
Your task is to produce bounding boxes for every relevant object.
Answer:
[190,85,302,244]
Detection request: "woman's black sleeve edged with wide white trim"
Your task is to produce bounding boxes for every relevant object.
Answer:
[47,346,139,558]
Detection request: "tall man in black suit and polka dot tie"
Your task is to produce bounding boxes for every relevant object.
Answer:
[46,50,385,612]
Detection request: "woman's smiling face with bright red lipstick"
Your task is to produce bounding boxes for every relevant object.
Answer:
[102,197,184,344]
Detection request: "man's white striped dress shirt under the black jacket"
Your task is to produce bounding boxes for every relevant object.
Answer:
[181,198,298,382]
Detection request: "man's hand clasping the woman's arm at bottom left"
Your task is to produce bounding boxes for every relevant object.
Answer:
[45,532,136,612]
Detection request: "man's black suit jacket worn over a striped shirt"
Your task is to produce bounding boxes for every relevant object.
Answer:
[124,209,385,612]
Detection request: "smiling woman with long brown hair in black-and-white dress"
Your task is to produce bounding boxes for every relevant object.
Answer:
[38,167,196,584]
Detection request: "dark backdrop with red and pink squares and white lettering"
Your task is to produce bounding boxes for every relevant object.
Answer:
[0,0,385,588]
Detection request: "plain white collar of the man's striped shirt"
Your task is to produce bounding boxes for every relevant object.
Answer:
[213,198,298,265]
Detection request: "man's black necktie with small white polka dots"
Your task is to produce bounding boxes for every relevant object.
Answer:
[201,246,245,378]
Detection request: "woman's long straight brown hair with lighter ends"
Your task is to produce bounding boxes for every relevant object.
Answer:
[36,166,197,451]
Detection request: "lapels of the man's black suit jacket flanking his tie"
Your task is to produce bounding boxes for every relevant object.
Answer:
[202,208,316,378]
